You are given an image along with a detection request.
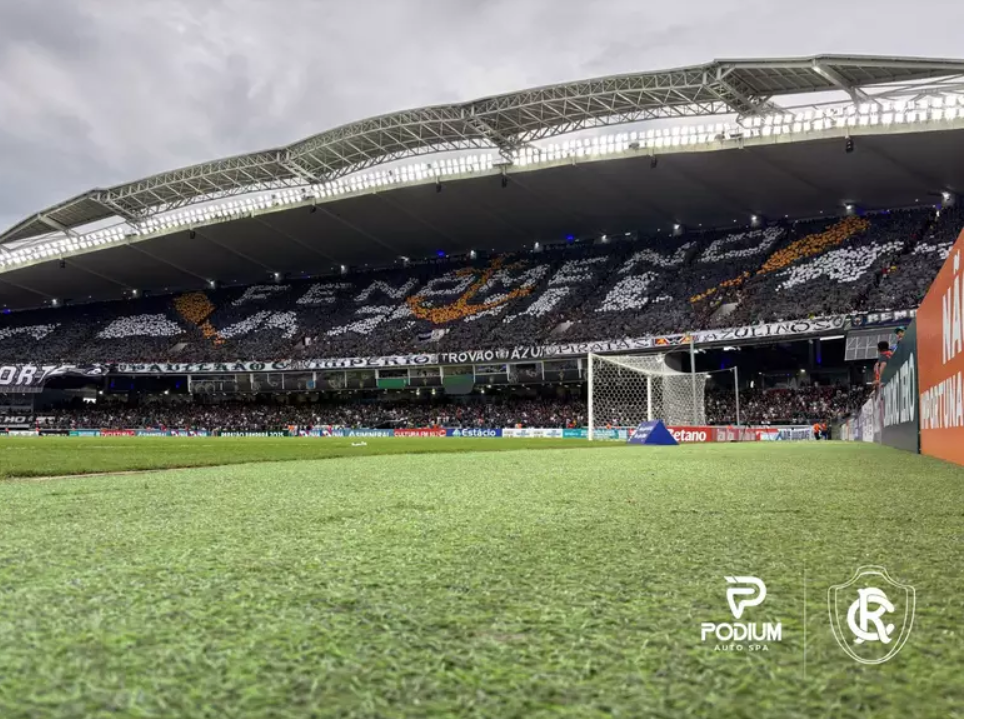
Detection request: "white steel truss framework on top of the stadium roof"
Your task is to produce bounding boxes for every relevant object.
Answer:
[0,55,964,246]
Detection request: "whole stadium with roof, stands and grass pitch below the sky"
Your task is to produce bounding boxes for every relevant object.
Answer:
[0,55,965,719]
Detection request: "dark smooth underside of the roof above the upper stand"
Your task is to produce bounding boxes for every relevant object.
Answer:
[0,123,964,310]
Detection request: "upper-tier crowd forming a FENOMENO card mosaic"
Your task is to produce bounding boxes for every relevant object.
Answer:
[0,206,963,364]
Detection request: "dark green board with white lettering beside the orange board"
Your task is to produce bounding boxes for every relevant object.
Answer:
[878,320,919,452]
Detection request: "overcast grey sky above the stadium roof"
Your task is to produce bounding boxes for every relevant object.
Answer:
[0,0,964,230]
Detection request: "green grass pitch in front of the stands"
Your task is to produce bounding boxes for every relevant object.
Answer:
[0,438,964,719]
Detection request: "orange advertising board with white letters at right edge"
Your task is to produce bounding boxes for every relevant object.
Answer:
[916,231,964,464]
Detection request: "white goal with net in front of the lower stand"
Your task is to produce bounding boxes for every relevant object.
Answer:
[587,354,708,439]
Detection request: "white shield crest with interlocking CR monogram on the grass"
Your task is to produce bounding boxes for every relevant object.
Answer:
[829,567,916,664]
